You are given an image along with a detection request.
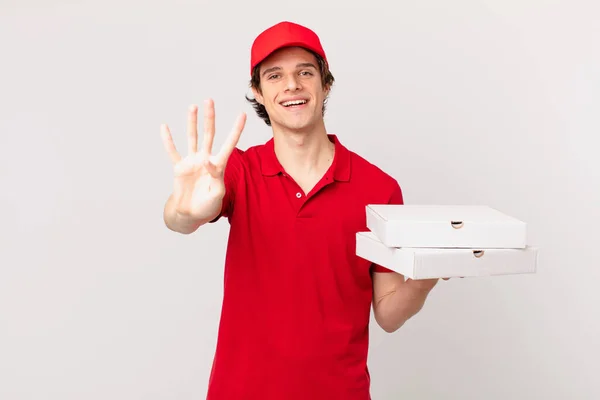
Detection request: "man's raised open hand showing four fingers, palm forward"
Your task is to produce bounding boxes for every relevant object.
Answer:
[161,100,246,224]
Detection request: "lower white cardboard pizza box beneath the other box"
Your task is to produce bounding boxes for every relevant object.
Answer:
[356,232,538,279]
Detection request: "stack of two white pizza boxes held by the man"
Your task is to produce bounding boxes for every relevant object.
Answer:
[356,204,538,279]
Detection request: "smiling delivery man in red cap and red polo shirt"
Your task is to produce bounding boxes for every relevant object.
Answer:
[162,22,437,400]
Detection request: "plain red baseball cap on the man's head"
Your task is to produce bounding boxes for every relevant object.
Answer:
[250,21,327,75]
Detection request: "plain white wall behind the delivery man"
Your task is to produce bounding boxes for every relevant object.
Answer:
[0,0,600,400]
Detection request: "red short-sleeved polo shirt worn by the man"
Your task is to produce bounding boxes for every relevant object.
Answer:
[207,135,402,400]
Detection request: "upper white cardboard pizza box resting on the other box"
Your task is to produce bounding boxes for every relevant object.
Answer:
[366,204,527,249]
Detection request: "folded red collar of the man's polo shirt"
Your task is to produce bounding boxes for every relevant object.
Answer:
[260,134,351,181]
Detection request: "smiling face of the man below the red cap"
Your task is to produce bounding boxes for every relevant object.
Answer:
[253,47,328,130]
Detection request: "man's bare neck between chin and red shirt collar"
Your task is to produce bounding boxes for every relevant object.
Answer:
[273,122,334,175]
